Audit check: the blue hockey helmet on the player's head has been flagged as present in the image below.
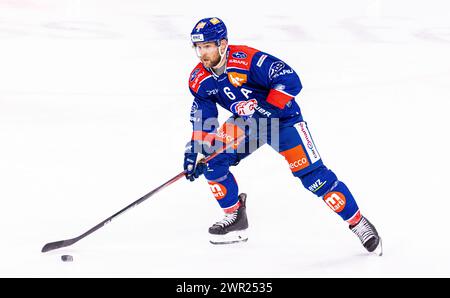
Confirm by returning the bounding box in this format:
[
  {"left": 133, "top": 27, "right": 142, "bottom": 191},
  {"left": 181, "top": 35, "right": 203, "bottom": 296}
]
[{"left": 191, "top": 17, "right": 228, "bottom": 45}]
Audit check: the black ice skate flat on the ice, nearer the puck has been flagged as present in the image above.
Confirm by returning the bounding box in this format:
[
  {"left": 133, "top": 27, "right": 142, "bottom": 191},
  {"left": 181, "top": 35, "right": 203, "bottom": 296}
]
[{"left": 209, "top": 193, "right": 248, "bottom": 244}]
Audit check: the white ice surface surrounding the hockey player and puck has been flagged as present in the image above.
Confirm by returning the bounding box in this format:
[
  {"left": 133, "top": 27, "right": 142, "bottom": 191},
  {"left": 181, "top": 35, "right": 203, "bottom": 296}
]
[{"left": 0, "top": 0, "right": 450, "bottom": 277}]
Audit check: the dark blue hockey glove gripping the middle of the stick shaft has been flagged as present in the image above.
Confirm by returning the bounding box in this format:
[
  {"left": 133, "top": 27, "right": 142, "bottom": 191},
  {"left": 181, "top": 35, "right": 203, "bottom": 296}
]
[{"left": 183, "top": 141, "right": 207, "bottom": 181}]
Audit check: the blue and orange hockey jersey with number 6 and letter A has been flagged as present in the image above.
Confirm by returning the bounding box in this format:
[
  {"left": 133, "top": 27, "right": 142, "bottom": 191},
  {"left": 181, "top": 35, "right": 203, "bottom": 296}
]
[{"left": 189, "top": 45, "right": 302, "bottom": 139}]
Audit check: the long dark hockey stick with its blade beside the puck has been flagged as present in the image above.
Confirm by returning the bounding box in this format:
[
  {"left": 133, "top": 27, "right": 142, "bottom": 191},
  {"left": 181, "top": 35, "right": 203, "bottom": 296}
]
[{"left": 42, "top": 136, "right": 245, "bottom": 252}]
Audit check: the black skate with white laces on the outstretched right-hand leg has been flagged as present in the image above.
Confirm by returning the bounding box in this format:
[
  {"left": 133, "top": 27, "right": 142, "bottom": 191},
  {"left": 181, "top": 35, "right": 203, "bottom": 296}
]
[{"left": 349, "top": 216, "right": 383, "bottom": 256}]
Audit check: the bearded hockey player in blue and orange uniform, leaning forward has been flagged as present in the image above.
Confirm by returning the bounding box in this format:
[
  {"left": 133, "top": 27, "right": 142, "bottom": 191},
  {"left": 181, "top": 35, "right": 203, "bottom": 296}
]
[{"left": 184, "top": 17, "right": 381, "bottom": 255}]
